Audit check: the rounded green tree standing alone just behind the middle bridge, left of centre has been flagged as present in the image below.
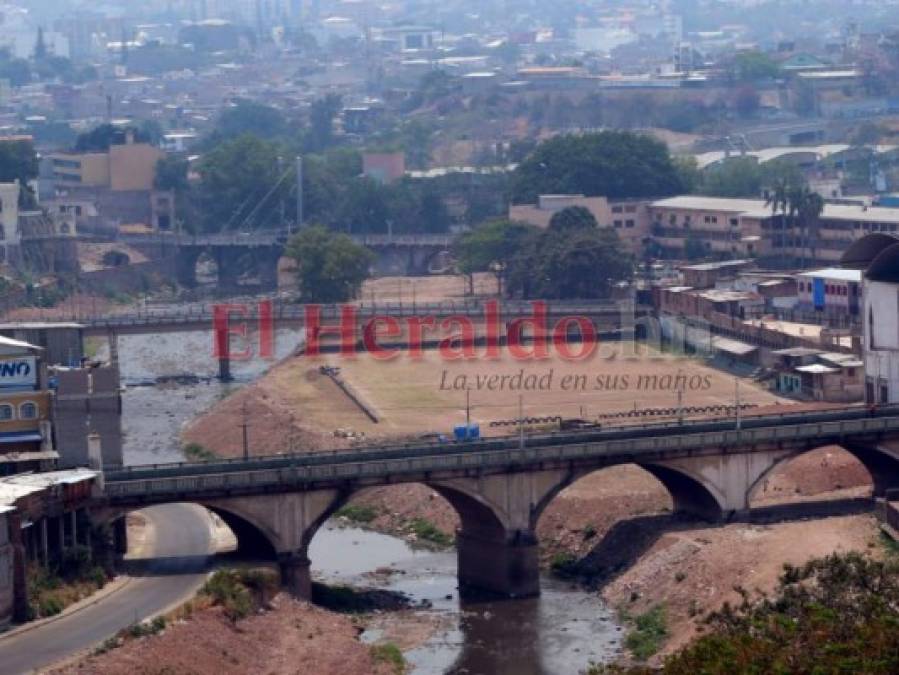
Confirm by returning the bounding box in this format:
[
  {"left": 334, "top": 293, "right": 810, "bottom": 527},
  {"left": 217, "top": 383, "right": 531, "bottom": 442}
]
[{"left": 286, "top": 225, "right": 374, "bottom": 303}]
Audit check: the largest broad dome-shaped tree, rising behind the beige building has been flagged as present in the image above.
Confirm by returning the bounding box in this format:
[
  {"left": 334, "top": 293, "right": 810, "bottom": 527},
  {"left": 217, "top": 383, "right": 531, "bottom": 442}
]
[{"left": 512, "top": 131, "right": 684, "bottom": 203}]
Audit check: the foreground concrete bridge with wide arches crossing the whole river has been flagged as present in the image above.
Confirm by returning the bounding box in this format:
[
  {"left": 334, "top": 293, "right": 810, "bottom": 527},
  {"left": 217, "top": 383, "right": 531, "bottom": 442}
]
[{"left": 94, "top": 407, "right": 899, "bottom": 598}]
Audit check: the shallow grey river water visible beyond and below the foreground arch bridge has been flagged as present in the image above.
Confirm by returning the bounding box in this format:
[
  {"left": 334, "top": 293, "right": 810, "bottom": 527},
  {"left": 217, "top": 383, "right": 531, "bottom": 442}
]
[{"left": 119, "top": 333, "right": 622, "bottom": 675}]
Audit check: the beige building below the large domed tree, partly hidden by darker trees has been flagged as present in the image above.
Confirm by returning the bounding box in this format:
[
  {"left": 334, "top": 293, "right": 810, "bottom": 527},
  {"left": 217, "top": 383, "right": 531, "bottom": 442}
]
[{"left": 509, "top": 195, "right": 649, "bottom": 255}]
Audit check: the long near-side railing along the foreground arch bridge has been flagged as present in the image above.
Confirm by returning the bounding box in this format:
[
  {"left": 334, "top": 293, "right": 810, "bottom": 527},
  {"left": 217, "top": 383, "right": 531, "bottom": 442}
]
[{"left": 106, "top": 417, "right": 899, "bottom": 500}]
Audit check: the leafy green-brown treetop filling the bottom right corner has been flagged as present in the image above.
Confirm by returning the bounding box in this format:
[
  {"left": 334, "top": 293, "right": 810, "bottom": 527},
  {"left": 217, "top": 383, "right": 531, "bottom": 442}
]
[{"left": 588, "top": 553, "right": 899, "bottom": 675}]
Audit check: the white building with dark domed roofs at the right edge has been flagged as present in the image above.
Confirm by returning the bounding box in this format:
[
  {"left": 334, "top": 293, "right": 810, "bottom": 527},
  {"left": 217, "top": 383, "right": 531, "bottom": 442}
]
[{"left": 843, "top": 233, "right": 899, "bottom": 404}]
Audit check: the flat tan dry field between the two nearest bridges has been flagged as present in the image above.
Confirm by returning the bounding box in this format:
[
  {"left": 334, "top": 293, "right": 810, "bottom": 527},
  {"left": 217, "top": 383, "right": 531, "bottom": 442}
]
[{"left": 261, "top": 345, "right": 789, "bottom": 437}]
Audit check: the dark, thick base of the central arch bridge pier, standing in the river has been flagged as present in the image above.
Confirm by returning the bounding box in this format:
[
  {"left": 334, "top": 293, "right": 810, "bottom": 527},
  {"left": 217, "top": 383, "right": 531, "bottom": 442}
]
[{"left": 456, "top": 532, "right": 540, "bottom": 598}]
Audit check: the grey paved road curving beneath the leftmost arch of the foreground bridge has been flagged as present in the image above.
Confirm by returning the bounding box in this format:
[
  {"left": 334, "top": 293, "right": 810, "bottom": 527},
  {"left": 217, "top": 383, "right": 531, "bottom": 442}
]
[{"left": 0, "top": 504, "right": 212, "bottom": 675}]
